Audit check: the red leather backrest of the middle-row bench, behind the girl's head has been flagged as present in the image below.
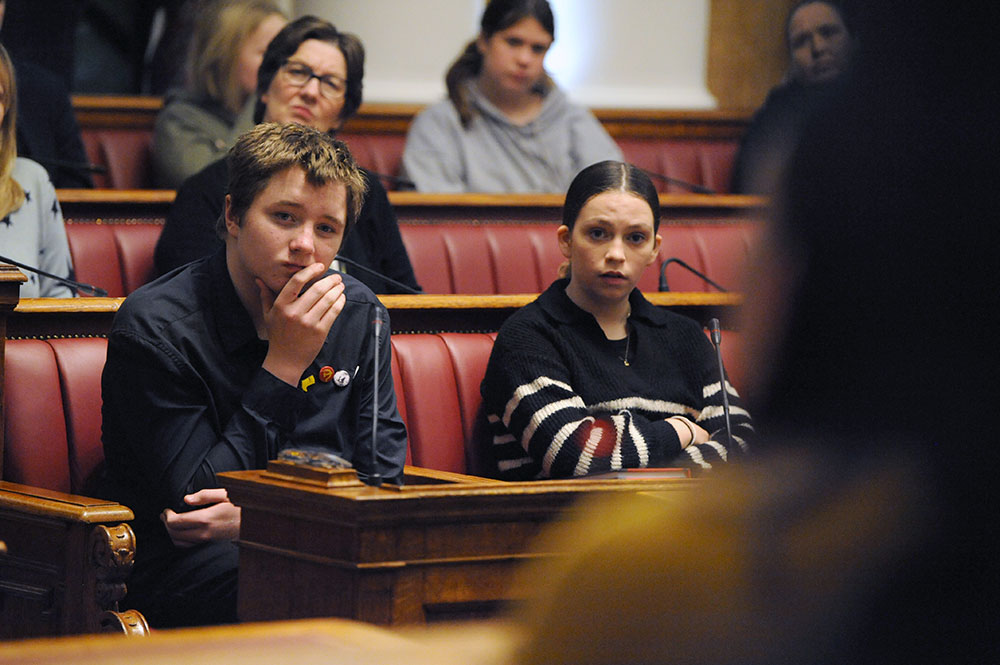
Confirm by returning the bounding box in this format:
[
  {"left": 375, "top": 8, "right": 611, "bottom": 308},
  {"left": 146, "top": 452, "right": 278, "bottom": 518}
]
[{"left": 60, "top": 222, "right": 759, "bottom": 297}]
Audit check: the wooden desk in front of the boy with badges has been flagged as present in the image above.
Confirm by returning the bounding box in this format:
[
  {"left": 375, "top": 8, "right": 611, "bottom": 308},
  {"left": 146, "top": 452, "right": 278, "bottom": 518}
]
[{"left": 219, "top": 467, "right": 697, "bottom": 625}]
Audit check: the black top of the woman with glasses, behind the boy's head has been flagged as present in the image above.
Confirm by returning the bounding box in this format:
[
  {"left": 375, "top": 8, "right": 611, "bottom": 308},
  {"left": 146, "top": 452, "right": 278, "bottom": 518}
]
[{"left": 154, "top": 158, "right": 420, "bottom": 293}]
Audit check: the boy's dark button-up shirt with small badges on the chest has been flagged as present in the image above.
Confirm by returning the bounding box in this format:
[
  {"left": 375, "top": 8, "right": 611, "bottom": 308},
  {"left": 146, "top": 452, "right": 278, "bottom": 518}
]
[{"left": 101, "top": 251, "right": 406, "bottom": 548}]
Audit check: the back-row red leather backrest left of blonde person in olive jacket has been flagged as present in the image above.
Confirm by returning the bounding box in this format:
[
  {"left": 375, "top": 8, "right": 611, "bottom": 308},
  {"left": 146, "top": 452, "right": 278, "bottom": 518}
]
[{"left": 80, "top": 128, "right": 153, "bottom": 189}]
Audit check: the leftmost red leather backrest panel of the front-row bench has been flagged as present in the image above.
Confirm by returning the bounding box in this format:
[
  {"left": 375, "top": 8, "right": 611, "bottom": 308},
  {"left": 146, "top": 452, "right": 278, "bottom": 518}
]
[{"left": 3, "top": 339, "right": 73, "bottom": 492}]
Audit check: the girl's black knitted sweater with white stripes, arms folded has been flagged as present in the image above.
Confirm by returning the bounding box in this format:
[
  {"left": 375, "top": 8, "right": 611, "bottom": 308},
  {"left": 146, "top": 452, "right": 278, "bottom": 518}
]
[{"left": 480, "top": 280, "right": 753, "bottom": 480}]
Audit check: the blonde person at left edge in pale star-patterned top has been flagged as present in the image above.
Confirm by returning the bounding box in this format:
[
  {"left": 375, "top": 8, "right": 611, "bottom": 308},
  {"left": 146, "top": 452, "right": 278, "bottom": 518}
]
[{"left": 0, "top": 46, "right": 75, "bottom": 298}]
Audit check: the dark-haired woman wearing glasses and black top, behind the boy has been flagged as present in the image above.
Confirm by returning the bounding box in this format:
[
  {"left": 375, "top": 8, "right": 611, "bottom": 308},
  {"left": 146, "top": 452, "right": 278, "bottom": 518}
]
[{"left": 155, "top": 16, "right": 420, "bottom": 293}]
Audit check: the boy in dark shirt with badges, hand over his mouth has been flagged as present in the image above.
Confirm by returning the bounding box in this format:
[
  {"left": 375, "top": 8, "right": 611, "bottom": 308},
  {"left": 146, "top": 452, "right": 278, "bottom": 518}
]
[{"left": 97, "top": 123, "right": 407, "bottom": 627}]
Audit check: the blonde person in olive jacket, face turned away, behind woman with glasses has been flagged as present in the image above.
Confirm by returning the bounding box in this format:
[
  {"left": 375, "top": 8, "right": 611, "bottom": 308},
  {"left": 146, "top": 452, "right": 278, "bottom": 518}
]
[{"left": 153, "top": 0, "right": 288, "bottom": 189}]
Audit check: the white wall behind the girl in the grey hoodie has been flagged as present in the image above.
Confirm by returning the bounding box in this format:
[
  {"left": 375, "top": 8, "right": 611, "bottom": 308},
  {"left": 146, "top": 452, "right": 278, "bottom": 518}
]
[{"left": 290, "top": 0, "right": 715, "bottom": 109}]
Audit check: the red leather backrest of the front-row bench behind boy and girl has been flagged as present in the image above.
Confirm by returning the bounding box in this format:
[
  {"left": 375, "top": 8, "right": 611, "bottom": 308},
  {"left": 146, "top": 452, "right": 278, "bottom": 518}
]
[{"left": 3, "top": 331, "right": 742, "bottom": 494}]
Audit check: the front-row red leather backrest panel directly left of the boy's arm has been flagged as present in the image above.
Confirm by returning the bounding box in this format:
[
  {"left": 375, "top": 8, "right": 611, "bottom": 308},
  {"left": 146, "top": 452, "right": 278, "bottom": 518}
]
[{"left": 49, "top": 337, "right": 108, "bottom": 494}]
